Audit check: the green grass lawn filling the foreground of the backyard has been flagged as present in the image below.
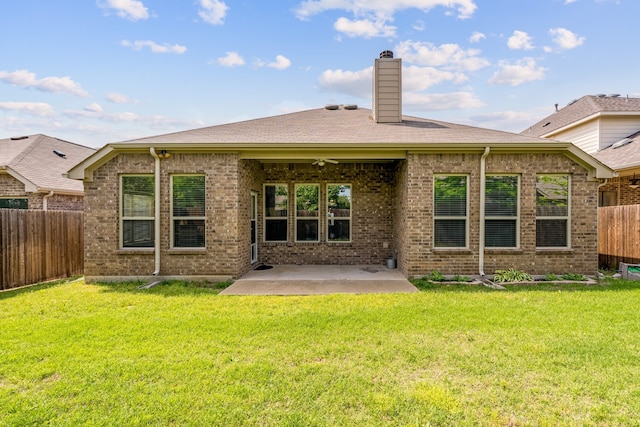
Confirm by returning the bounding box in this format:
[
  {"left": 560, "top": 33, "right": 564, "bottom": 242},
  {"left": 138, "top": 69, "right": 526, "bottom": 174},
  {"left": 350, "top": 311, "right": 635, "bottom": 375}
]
[{"left": 0, "top": 280, "right": 640, "bottom": 426}]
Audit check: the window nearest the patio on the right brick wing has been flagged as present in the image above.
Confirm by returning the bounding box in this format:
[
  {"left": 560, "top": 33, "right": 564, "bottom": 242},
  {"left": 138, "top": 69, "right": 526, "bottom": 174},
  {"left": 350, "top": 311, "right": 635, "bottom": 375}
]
[{"left": 433, "top": 175, "right": 468, "bottom": 248}]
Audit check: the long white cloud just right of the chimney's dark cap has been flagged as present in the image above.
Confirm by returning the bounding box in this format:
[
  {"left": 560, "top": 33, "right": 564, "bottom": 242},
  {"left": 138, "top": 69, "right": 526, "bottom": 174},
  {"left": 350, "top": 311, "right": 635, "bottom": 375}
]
[{"left": 396, "top": 40, "right": 489, "bottom": 71}]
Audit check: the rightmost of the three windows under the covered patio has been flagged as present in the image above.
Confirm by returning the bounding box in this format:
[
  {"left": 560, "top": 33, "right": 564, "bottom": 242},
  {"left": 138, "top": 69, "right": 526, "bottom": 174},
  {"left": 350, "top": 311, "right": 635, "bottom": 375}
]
[{"left": 327, "top": 184, "right": 351, "bottom": 242}]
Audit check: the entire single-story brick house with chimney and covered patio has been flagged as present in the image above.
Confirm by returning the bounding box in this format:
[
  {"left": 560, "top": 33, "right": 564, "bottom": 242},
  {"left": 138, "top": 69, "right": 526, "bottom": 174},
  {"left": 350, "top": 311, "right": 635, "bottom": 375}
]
[{"left": 69, "top": 55, "right": 613, "bottom": 281}]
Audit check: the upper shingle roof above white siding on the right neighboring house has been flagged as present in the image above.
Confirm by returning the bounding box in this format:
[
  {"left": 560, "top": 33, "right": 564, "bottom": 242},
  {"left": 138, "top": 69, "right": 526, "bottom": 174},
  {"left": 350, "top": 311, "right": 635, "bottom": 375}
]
[{"left": 520, "top": 95, "right": 640, "bottom": 137}]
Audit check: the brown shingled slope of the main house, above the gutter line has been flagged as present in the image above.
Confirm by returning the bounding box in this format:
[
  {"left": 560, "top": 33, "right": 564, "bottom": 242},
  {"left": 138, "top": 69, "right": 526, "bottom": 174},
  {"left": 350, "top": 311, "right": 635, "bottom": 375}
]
[{"left": 118, "top": 108, "right": 548, "bottom": 145}]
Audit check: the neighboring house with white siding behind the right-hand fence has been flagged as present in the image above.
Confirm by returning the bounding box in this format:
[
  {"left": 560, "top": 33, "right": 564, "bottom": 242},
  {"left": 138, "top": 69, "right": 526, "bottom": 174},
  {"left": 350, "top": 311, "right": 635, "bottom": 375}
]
[{"left": 522, "top": 94, "right": 640, "bottom": 206}]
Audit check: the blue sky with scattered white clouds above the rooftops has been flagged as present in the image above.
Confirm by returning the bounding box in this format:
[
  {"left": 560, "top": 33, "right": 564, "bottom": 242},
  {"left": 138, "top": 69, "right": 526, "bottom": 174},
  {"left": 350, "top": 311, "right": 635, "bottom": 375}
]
[{"left": 0, "top": 0, "right": 640, "bottom": 147}]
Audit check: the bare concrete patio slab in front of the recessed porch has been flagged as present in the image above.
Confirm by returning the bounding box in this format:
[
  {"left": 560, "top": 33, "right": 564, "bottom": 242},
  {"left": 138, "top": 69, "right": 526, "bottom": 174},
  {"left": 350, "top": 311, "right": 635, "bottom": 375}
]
[{"left": 220, "top": 265, "right": 418, "bottom": 295}]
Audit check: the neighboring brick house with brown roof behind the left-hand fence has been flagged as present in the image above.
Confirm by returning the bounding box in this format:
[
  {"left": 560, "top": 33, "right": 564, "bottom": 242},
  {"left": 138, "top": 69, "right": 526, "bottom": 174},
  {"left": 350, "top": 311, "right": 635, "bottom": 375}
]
[{"left": 0, "top": 135, "right": 96, "bottom": 211}]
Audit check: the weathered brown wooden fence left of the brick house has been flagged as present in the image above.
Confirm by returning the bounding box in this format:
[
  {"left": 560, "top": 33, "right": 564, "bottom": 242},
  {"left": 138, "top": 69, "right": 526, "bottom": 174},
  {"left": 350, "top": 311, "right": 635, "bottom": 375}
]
[{"left": 0, "top": 209, "right": 84, "bottom": 289}]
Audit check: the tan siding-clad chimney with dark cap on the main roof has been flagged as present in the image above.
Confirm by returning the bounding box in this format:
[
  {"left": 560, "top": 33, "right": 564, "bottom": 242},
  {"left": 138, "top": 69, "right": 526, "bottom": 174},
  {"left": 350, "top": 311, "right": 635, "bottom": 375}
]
[{"left": 373, "top": 50, "right": 402, "bottom": 123}]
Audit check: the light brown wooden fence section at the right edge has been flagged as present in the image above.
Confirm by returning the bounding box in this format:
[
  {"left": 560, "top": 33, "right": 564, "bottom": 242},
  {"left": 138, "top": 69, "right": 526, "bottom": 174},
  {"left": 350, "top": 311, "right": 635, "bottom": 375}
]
[{"left": 598, "top": 205, "right": 640, "bottom": 269}]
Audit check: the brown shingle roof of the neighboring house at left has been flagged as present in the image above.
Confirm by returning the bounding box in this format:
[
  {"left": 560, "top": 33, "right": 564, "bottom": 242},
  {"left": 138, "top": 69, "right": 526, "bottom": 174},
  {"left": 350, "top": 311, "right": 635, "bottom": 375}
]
[{"left": 0, "top": 134, "right": 96, "bottom": 194}]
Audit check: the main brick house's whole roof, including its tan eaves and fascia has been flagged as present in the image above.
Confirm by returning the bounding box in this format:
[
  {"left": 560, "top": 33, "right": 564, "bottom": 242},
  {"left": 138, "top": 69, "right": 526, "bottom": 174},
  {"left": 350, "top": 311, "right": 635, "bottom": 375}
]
[{"left": 69, "top": 107, "right": 611, "bottom": 179}]
